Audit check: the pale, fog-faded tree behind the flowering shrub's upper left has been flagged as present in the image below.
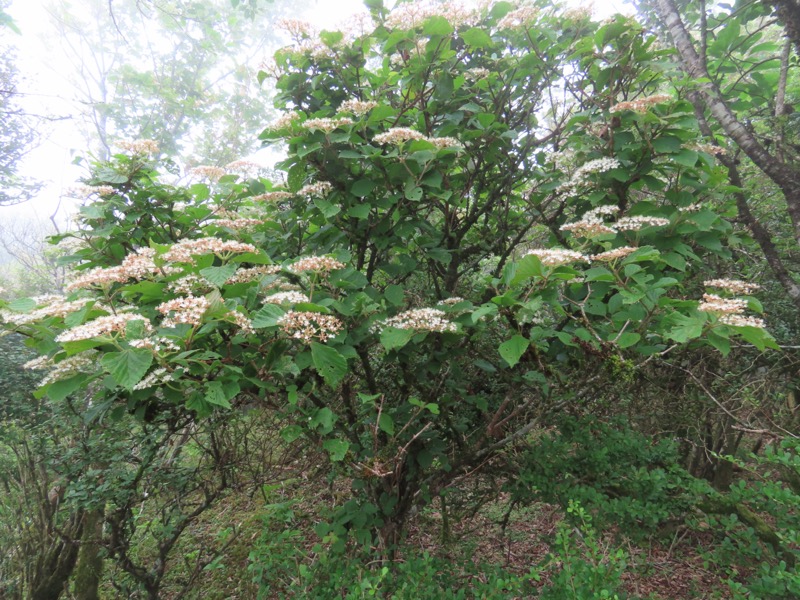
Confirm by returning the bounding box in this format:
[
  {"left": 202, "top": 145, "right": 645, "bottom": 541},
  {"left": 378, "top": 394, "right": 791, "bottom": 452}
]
[{"left": 45, "top": 0, "right": 306, "bottom": 164}]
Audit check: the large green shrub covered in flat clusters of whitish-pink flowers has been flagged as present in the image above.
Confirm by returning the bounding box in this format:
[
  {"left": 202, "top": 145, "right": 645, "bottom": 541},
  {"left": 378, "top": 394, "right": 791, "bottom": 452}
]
[{"left": 4, "top": 0, "right": 774, "bottom": 548}]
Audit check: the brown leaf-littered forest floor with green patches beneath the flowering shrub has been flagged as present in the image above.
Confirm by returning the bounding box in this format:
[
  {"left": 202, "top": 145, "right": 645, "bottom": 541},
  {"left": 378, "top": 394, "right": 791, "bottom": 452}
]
[{"left": 163, "top": 473, "right": 741, "bottom": 600}]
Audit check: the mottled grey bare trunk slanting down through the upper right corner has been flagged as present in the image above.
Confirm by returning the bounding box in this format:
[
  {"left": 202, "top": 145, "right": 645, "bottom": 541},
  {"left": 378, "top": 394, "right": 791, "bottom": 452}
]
[{"left": 654, "top": 0, "right": 800, "bottom": 244}]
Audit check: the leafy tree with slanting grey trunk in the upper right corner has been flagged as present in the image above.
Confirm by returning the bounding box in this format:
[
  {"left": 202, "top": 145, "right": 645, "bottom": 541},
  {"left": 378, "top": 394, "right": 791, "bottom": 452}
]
[{"left": 640, "top": 0, "right": 800, "bottom": 307}]
